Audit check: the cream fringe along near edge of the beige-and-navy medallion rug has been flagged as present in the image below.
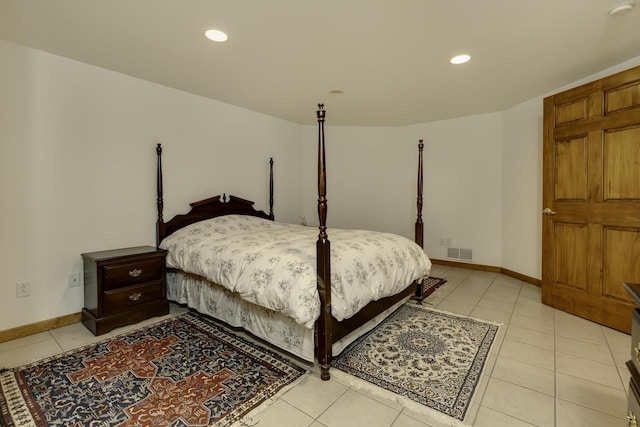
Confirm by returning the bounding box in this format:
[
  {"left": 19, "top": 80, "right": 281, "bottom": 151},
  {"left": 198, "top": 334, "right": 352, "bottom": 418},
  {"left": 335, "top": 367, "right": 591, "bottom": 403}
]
[{"left": 331, "top": 368, "right": 471, "bottom": 427}]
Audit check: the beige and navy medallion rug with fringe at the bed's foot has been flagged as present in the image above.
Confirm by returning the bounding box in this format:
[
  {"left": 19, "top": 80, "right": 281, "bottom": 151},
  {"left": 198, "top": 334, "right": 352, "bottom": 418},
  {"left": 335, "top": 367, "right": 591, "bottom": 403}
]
[{"left": 331, "top": 302, "right": 499, "bottom": 426}]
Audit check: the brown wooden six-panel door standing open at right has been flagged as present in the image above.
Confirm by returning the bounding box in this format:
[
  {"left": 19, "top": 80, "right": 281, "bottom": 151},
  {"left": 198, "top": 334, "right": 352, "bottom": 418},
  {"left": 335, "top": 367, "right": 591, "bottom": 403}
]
[{"left": 542, "top": 67, "right": 640, "bottom": 333}]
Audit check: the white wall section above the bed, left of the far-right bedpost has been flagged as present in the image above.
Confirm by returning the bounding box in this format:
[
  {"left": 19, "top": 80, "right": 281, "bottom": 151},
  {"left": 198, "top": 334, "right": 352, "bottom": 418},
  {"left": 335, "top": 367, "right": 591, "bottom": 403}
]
[{"left": 303, "top": 124, "right": 417, "bottom": 240}]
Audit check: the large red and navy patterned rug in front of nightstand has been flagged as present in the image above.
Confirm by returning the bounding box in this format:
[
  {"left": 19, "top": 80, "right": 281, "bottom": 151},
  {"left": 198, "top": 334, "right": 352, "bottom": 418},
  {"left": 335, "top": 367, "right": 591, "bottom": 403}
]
[{"left": 0, "top": 313, "right": 305, "bottom": 426}]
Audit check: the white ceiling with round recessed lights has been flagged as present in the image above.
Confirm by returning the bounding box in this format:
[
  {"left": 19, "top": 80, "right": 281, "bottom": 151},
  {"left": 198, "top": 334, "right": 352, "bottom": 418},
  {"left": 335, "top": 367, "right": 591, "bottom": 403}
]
[{"left": 0, "top": 0, "right": 640, "bottom": 126}]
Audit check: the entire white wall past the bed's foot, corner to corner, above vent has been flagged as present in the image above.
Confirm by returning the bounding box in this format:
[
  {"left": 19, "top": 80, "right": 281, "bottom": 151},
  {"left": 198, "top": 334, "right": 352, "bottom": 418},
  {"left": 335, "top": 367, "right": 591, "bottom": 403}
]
[{"left": 303, "top": 113, "right": 502, "bottom": 266}]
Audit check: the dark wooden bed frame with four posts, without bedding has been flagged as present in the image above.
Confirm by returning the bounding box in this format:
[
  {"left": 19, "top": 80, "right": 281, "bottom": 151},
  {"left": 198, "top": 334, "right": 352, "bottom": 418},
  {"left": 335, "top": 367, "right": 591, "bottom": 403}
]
[{"left": 156, "top": 104, "right": 424, "bottom": 380}]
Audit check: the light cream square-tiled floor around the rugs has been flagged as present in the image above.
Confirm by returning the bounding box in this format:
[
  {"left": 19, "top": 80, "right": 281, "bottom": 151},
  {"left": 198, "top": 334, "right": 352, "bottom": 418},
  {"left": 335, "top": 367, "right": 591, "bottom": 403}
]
[{"left": 0, "top": 265, "right": 631, "bottom": 427}]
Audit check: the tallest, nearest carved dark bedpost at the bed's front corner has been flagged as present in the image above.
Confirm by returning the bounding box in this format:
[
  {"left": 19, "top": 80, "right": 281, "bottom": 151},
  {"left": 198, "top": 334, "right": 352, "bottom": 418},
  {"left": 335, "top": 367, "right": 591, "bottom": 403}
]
[{"left": 316, "top": 104, "right": 333, "bottom": 381}]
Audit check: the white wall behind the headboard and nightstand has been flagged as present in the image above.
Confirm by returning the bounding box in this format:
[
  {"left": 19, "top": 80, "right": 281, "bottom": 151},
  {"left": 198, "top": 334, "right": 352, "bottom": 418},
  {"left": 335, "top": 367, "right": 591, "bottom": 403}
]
[{"left": 0, "top": 41, "right": 302, "bottom": 330}]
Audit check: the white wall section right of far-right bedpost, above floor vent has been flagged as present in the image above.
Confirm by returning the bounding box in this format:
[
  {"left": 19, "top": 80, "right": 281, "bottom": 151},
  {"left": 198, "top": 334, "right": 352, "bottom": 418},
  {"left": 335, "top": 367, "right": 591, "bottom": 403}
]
[{"left": 405, "top": 113, "right": 502, "bottom": 266}]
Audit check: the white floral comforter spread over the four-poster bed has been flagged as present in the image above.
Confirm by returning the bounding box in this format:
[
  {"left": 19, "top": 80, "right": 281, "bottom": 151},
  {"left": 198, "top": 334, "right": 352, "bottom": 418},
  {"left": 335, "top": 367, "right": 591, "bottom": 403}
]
[{"left": 160, "top": 215, "right": 431, "bottom": 328}]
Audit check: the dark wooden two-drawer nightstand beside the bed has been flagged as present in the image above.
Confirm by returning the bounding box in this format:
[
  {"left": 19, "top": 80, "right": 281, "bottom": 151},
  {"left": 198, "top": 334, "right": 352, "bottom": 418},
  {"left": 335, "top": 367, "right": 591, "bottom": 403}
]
[{"left": 82, "top": 246, "right": 169, "bottom": 335}]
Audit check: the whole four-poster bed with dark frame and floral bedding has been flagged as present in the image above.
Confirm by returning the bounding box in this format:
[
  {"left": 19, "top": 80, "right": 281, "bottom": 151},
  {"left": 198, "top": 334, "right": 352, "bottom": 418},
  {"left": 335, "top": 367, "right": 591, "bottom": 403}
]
[{"left": 156, "top": 104, "right": 431, "bottom": 380}]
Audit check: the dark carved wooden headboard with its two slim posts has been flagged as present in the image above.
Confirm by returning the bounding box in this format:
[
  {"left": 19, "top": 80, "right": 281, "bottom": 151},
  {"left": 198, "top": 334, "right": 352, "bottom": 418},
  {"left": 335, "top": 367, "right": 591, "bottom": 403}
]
[{"left": 156, "top": 144, "right": 274, "bottom": 247}]
